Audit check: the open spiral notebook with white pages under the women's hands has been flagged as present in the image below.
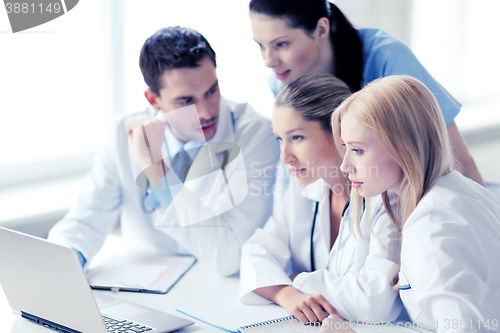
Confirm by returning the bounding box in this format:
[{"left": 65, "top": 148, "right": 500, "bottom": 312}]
[{"left": 177, "top": 296, "right": 431, "bottom": 333}]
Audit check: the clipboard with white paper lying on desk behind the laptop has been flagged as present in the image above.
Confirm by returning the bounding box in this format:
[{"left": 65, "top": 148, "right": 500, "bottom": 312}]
[{"left": 87, "top": 255, "right": 196, "bottom": 294}]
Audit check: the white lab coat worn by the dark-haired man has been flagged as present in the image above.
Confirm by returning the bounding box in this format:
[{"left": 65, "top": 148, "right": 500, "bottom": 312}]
[{"left": 49, "top": 97, "right": 279, "bottom": 276}]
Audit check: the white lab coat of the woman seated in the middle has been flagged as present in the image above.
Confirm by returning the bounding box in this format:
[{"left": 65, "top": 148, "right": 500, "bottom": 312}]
[{"left": 240, "top": 164, "right": 401, "bottom": 322}]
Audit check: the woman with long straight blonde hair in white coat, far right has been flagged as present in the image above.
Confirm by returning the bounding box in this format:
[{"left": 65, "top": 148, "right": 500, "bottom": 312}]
[{"left": 324, "top": 76, "right": 500, "bottom": 332}]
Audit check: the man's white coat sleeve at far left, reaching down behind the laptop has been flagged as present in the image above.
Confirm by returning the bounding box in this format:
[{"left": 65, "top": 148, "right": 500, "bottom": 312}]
[{"left": 48, "top": 118, "right": 126, "bottom": 263}]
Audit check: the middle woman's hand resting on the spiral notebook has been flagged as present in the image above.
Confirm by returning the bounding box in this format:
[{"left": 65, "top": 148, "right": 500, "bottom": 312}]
[{"left": 275, "top": 286, "right": 338, "bottom": 324}]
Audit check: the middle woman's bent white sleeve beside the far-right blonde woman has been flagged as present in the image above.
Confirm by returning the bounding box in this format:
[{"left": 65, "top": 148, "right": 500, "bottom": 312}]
[{"left": 293, "top": 208, "right": 401, "bottom": 322}]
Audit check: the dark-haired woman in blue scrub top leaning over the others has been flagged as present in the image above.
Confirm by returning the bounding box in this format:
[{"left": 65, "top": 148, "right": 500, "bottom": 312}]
[{"left": 249, "top": 0, "right": 484, "bottom": 186}]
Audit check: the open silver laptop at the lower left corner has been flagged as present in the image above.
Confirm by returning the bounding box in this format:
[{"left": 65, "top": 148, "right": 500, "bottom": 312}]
[{"left": 0, "top": 227, "right": 194, "bottom": 333}]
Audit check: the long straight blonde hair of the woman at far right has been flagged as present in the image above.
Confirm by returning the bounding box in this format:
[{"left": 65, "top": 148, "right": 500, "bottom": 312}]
[{"left": 332, "top": 75, "right": 454, "bottom": 230}]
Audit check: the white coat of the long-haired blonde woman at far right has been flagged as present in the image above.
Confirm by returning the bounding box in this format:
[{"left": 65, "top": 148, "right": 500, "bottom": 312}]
[{"left": 399, "top": 171, "right": 500, "bottom": 332}]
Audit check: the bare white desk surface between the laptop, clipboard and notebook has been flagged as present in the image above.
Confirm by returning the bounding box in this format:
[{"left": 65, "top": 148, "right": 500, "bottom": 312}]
[{"left": 0, "top": 262, "right": 239, "bottom": 333}]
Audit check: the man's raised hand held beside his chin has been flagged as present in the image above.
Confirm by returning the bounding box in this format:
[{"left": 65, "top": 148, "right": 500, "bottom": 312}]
[{"left": 127, "top": 115, "right": 168, "bottom": 187}]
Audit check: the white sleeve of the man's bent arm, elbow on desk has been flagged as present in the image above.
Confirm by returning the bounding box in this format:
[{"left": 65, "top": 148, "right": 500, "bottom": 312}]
[{"left": 155, "top": 113, "right": 279, "bottom": 276}]
